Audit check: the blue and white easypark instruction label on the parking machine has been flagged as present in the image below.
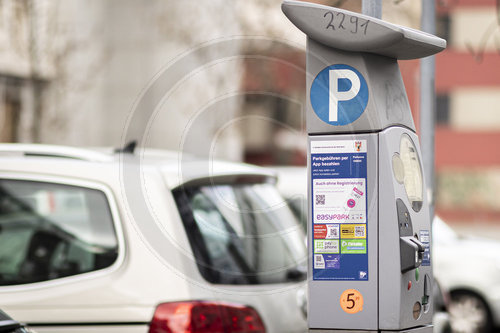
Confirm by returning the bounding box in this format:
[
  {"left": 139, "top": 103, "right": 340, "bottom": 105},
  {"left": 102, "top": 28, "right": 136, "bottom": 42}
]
[{"left": 311, "top": 140, "right": 368, "bottom": 281}]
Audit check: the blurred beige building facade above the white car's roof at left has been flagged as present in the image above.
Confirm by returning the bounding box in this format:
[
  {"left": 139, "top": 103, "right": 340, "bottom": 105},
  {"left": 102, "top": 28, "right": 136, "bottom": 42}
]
[{"left": 0, "top": 0, "right": 248, "bottom": 160}]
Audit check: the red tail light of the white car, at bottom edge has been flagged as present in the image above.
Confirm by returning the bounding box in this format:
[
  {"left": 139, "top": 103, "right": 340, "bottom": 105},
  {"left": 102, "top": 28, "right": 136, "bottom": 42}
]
[{"left": 149, "top": 301, "right": 266, "bottom": 333}]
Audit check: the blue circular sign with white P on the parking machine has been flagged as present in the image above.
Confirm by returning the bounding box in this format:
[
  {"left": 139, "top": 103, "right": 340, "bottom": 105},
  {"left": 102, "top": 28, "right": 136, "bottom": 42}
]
[{"left": 310, "top": 64, "right": 368, "bottom": 126}]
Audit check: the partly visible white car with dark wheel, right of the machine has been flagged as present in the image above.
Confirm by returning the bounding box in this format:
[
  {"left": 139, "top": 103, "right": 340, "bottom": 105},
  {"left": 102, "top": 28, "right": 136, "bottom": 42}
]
[{"left": 433, "top": 217, "right": 500, "bottom": 333}]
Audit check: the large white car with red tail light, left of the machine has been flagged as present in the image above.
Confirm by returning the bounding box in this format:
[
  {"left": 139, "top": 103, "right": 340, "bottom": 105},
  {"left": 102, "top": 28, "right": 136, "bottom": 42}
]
[{"left": 0, "top": 144, "right": 307, "bottom": 333}]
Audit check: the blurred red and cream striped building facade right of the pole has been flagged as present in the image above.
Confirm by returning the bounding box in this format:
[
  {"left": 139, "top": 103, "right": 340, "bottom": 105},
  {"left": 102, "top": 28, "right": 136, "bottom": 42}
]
[{"left": 414, "top": 0, "right": 500, "bottom": 223}]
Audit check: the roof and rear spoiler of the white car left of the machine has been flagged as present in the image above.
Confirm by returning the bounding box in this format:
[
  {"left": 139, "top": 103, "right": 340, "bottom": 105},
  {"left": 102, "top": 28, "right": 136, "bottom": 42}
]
[{"left": 0, "top": 143, "right": 275, "bottom": 189}]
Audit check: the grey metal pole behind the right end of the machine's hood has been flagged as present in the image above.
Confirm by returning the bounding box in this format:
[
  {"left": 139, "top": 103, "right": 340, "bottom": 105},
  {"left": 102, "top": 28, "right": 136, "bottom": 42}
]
[{"left": 420, "top": 0, "right": 436, "bottom": 221}]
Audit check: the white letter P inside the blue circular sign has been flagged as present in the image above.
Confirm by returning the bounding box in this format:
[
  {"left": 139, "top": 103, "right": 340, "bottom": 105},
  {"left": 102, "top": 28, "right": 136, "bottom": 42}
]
[{"left": 328, "top": 69, "right": 361, "bottom": 121}]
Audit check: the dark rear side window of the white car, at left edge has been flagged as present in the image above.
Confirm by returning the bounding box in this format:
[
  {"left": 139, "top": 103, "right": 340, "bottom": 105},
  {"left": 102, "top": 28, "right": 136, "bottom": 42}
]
[{"left": 0, "top": 179, "right": 118, "bottom": 286}]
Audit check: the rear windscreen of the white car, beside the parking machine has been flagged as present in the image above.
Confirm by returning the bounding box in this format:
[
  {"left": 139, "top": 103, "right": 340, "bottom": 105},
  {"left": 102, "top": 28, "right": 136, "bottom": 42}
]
[{"left": 174, "top": 180, "right": 306, "bottom": 284}]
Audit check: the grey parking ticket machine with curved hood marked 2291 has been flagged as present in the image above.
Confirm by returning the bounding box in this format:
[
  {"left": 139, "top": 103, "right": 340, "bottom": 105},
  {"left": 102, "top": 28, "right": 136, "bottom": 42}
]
[{"left": 282, "top": 0, "right": 446, "bottom": 332}]
